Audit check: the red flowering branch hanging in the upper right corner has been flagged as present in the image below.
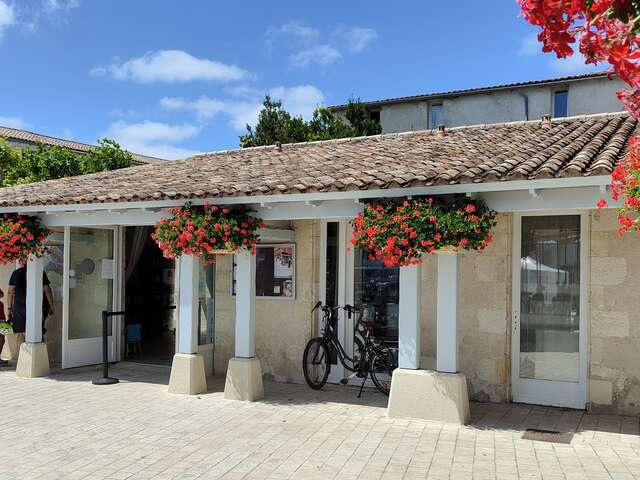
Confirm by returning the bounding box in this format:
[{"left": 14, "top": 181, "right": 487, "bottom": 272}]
[{"left": 518, "top": 0, "right": 640, "bottom": 234}]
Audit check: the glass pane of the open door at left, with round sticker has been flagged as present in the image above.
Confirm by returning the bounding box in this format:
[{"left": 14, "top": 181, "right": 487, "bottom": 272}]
[{"left": 69, "top": 228, "right": 115, "bottom": 340}]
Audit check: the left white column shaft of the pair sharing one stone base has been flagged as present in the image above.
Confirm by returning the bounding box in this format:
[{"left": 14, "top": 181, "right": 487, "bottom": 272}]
[{"left": 398, "top": 265, "right": 422, "bottom": 370}]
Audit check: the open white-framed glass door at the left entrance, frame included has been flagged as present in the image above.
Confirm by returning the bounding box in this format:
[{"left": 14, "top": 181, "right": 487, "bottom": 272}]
[{"left": 62, "top": 227, "right": 120, "bottom": 368}]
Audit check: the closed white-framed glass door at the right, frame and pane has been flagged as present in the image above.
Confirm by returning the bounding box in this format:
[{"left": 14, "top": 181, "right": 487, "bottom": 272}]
[{"left": 512, "top": 215, "right": 586, "bottom": 408}]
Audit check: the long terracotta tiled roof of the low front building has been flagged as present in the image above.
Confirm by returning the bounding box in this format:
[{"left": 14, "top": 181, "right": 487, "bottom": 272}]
[{"left": 0, "top": 113, "right": 636, "bottom": 207}]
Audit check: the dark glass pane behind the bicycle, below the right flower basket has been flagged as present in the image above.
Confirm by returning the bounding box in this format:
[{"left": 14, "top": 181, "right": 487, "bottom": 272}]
[{"left": 354, "top": 249, "right": 400, "bottom": 343}]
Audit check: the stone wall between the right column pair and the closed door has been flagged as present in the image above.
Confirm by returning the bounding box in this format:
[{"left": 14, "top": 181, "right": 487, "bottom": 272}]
[{"left": 421, "top": 214, "right": 513, "bottom": 402}]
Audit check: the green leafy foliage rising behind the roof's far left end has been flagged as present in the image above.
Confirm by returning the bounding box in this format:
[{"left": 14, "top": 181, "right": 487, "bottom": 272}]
[{"left": 0, "top": 138, "right": 132, "bottom": 186}]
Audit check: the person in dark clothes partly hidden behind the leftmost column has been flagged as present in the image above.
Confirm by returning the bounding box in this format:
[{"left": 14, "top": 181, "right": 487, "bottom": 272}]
[{"left": 7, "top": 262, "right": 53, "bottom": 352}]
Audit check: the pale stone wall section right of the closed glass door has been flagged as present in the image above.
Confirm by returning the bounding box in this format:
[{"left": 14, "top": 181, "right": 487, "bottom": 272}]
[{"left": 589, "top": 210, "right": 640, "bottom": 415}]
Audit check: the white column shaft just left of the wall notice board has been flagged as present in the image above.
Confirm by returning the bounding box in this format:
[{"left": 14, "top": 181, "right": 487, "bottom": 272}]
[{"left": 235, "top": 250, "right": 256, "bottom": 358}]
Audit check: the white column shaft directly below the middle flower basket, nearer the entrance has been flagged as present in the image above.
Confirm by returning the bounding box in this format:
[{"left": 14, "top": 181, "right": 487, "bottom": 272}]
[{"left": 177, "top": 255, "right": 200, "bottom": 353}]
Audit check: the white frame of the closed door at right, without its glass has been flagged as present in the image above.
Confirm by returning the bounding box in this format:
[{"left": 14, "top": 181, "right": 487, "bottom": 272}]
[{"left": 511, "top": 210, "right": 589, "bottom": 409}]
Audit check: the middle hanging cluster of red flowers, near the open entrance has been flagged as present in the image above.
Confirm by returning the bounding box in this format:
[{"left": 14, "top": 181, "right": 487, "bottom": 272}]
[{"left": 152, "top": 203, "right": 263, "bottom": 264}]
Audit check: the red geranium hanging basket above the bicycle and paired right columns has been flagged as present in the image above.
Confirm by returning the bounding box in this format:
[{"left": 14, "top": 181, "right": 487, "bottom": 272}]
[{"left": 351, "top": 198, "right": 496, "bottom": 267}]
